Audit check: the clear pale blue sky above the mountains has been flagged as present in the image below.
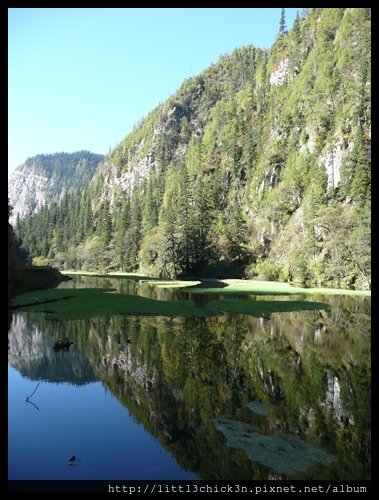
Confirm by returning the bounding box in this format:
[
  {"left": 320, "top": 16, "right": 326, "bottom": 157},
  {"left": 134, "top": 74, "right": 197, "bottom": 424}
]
[{"left": 8, "top": 8, "right": 301, "bottom": 173}]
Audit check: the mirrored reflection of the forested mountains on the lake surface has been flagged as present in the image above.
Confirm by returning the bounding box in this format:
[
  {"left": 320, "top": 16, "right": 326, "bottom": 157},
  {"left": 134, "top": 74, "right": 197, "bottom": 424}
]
[{"left": 9, "top": 292, "right": 370, "bottom": 479}]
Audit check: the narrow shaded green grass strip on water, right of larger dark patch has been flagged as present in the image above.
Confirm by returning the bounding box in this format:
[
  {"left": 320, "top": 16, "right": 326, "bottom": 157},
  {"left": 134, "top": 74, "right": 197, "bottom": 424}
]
[{"left": 208, "top": 300, "right": 330, "bottom": 317}]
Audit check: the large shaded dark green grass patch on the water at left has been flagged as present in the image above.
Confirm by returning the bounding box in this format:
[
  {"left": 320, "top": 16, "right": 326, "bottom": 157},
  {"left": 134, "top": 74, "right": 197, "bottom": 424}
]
[{"left": 12, "top": 288, "right": 219, "bottom": 320}]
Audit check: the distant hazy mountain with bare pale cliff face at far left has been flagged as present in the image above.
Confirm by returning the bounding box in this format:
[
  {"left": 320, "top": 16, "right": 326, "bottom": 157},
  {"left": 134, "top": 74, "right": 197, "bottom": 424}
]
[{"left": 8, "top": 151, "right": 104, "bottom": 223}]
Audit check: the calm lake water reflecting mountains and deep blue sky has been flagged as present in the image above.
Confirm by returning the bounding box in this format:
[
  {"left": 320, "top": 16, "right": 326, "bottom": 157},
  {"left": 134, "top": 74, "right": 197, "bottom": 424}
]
[{"left": 8, "top": 277, "right": 371, "bottom": 480}]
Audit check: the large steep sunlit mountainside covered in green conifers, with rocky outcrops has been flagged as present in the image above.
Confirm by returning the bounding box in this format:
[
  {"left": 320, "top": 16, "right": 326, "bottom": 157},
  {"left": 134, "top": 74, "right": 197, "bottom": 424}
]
[{"left": 16, "top": 8, "right": 371, "bottom": 288}]
